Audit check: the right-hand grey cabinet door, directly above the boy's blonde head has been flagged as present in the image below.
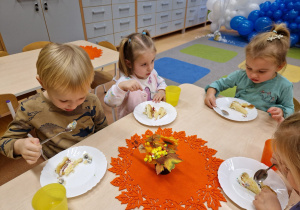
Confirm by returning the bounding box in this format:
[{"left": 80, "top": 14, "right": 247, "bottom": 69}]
[{"left": 41, "top": 0, "right": 84, "bottom": 43}]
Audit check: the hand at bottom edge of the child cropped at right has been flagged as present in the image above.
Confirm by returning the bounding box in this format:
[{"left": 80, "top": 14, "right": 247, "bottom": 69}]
[{"left": 253, "top": 187, "right": 281, "bottom": 210}]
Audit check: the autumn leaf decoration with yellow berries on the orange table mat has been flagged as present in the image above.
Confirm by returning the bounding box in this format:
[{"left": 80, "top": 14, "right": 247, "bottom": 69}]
[{"left": 139, "top": 134, "right": 182, "bottom": 175}]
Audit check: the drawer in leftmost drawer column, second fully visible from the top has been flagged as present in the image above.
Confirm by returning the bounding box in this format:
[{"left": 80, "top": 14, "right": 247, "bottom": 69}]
[{"left": 86, "top": 20, "right": 113, "bottom": 38}]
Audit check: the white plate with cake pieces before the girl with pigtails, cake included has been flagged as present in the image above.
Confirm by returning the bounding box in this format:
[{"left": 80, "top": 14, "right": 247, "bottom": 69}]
[{"left": 133, "top": 101, "right": 177, "bottom": 126}]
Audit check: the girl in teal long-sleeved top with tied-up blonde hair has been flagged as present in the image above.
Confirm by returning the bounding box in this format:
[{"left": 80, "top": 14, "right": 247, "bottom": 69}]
[{"left": 205, "top": 24, "right": 294, "bottom": 122}]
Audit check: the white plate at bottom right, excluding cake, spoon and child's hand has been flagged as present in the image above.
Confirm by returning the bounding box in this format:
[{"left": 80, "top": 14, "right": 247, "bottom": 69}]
[{"left": 218, "top": 157, "right": 288, "bottom": 210}]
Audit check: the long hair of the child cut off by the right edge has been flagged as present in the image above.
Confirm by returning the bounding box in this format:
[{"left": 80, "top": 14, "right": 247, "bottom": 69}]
[{"left": 273, "top": 112, "right": 300, "bottom": 188}]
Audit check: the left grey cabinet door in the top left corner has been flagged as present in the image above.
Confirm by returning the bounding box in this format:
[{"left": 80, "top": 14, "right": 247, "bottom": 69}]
[{"left": 0, "top": 0, "right": 49, "bottom": 54}]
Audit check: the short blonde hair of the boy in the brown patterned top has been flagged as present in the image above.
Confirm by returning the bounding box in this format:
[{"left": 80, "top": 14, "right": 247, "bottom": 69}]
[{"left": 36, "top": 43, "right": 94, "bottom": 92}]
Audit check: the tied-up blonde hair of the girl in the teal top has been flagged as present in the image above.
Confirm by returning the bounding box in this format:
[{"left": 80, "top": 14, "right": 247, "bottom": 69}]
[{"left": 245, "top": 24, "right": 290, "bottom": 66}]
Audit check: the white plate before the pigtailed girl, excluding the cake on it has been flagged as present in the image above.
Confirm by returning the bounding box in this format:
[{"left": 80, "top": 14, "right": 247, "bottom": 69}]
[{"left": 133, "top": 101, "right": 177, "bottom": 126}]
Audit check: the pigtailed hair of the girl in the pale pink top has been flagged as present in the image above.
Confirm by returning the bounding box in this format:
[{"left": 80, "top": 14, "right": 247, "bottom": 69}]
[{"left": 119, "top": 30, "right": 156, "bottom": 77}]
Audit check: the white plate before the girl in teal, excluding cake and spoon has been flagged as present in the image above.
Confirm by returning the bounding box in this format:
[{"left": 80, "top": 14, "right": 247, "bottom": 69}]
[{"left": 213, "top": 97, "right": 257, "bottom": 121}]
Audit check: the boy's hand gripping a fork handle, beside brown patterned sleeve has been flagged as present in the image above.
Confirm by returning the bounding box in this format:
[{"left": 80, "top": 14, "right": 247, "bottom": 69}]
[{"left": 14, "top": 138, "right": 42, "bottom": 164}]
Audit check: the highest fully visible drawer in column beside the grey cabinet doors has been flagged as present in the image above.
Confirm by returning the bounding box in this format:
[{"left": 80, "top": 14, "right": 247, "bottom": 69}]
[{"left": 83, "top": 6, "right": 112, "bottom": 23}]
